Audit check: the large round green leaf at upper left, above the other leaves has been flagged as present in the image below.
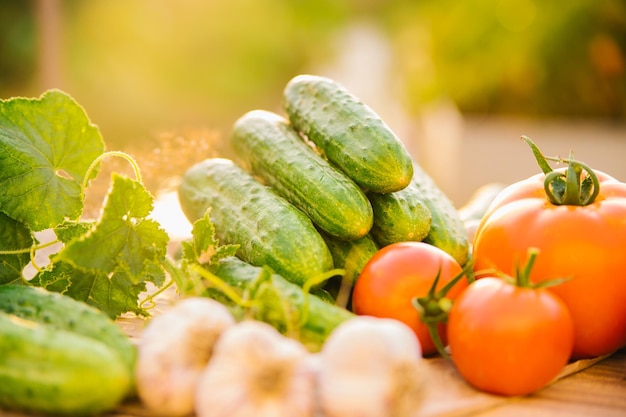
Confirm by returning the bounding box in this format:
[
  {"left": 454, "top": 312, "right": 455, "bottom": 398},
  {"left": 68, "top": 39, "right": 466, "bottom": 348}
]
[{"left": 0, "top": 90, "right": 105, "bottom": 231}]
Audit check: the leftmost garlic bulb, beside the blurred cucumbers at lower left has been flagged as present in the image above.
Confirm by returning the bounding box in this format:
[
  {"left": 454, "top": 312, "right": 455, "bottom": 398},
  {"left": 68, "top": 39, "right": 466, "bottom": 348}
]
[{"left": 135, "top": 297, "right": 236, "bottom": 417}]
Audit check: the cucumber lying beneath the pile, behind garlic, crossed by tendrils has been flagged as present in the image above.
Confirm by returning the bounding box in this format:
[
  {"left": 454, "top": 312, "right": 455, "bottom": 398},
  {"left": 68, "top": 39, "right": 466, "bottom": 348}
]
[{"left": 210, "top": 257, "right": 354, "bottom": 351}]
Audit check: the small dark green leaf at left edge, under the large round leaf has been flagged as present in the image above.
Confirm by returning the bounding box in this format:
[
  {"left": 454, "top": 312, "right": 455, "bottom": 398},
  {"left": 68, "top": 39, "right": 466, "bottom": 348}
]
[{"left": 0, "top": 212, "right": 35, "bottom": 285}]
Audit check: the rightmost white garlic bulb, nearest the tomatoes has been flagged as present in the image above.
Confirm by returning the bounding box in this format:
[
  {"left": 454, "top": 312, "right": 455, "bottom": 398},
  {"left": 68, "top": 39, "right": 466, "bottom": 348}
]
[{"left": 318, "top": 316, "right": 425, "bottom": 417}]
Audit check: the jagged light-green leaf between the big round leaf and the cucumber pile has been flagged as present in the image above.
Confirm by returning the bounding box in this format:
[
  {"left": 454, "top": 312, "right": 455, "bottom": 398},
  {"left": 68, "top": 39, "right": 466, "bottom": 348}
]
[{"left": 54, "top": 173, "right": 169, "bottom": 283}]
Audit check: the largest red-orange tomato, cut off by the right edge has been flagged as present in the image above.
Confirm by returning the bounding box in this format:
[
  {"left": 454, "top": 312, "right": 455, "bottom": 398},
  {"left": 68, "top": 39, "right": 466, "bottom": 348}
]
[{"left": 473, "top": 171, "right": 626, "bottom": 359}]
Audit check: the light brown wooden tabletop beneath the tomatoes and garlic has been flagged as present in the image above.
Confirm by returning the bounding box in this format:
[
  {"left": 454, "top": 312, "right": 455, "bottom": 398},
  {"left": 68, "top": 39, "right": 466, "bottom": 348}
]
[{"left": 107, "top": 349, "right": 626, "bottom": 417}]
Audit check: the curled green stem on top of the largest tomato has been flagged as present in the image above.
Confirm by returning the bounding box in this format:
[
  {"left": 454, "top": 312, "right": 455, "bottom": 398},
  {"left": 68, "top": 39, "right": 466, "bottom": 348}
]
[{"left": 522, "top": 136, "right": 600, "bottom": 206}]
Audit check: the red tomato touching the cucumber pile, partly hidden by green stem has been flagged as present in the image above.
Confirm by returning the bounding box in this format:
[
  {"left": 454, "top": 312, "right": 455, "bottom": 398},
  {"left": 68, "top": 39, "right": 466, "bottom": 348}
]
[{"left": 352, "top": 242, "right": 467, "bottom": 356}]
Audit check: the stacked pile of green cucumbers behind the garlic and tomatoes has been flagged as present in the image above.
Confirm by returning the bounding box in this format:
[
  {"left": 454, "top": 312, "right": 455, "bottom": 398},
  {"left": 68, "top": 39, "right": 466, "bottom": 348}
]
[{"left": 178, "top": 75, "right": 469, "bottom": 294}]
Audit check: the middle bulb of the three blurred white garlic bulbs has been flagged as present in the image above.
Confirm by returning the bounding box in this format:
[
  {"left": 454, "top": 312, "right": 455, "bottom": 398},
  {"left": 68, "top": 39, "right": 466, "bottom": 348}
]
[{"left": 195, "top": 320, "right": 315, "bottom": 417}]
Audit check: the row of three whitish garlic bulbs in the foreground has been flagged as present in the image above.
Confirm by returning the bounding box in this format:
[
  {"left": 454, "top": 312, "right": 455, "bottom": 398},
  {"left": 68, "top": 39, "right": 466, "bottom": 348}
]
[{"left": 132, "top": 297, "right": 424, "bottom": 417}]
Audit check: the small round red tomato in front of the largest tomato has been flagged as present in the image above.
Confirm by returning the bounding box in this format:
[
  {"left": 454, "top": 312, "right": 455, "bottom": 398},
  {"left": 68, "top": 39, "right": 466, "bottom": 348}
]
[{"left": 448, "top": 276, "right": 574, "bottom": 396}]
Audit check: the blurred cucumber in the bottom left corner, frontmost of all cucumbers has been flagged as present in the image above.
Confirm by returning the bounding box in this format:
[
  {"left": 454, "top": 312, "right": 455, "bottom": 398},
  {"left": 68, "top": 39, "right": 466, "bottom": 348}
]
[{"left": 0, "top": 312, "right": 130, "bottom": 416}]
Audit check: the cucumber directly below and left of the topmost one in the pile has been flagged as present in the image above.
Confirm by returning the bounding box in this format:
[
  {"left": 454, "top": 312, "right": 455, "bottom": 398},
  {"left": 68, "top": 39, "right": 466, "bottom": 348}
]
[{"left": 231, "top": 110, "right": 373, "bottom": 240}]
